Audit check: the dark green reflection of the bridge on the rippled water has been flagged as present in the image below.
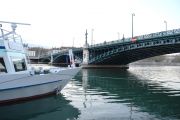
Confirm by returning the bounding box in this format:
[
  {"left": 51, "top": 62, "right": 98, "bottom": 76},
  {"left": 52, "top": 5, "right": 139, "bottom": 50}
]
[{"left": 76, "top": 69, "right": 180, "bottom": 119}]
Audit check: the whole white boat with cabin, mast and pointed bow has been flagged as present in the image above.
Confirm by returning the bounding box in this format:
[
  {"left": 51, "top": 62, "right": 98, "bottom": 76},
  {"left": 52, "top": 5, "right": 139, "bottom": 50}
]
[{"left": 0, "top": 21, "right": 80, "bottom": 104}]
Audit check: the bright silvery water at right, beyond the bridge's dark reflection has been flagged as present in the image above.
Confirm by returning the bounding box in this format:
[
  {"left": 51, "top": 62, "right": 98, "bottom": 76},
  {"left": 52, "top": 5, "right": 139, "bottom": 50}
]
[{"left": 129, "top": 66, "right": 180, "bottom": 90}]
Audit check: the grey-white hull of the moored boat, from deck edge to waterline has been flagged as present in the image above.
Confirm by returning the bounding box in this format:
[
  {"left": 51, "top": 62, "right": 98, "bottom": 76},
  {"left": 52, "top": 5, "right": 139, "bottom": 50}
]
[{"left": 0, "top": 68, "right": 79, "bottom": 104}]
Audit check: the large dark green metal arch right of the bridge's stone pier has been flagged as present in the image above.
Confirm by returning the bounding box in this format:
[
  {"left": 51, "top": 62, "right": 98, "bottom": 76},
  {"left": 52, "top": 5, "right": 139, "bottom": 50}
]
[{"left": 89, "top": 35, "right": 180, "bottom": 65}]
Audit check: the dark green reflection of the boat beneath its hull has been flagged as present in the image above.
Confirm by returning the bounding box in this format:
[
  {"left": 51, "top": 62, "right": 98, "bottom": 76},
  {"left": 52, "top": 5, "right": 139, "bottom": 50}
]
[{"left": 0, "top": 95, "right": 80, "bottom": 120}]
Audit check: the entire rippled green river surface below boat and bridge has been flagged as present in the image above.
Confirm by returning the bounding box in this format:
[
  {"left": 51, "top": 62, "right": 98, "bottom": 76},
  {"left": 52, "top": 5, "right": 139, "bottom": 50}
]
[{"left": 0, "top": 66, "right": 180, "bottom": 120}]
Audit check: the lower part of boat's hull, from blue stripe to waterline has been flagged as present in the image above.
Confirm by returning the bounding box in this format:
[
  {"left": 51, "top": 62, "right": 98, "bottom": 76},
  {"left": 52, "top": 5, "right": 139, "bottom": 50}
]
[{"left": 0, "top": 82, "right": 61, "bottom": 104}]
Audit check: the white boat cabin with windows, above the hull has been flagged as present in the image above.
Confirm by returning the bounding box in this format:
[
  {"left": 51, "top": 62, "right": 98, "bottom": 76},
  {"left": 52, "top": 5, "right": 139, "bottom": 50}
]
[{"left": 0, "top": 25, "right": 28, "bottom": 74}]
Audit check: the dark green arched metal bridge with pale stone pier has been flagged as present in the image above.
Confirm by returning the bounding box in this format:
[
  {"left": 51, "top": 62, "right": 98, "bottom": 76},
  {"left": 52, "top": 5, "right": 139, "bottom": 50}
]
[{"left": 40, "top": 29, "right": 180, "bottom": 66}]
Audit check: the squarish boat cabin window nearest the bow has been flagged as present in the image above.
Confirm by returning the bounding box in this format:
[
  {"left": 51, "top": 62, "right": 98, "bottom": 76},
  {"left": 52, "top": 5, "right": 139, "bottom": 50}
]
[{"left": 12, "top": 58, "right": 27, "bottom": 72}]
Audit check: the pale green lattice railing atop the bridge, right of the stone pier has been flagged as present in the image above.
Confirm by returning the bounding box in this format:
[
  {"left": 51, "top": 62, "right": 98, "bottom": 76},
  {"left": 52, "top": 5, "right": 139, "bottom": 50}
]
[{"left": 89, "top": 29, "right": 180, "bottom": 47}]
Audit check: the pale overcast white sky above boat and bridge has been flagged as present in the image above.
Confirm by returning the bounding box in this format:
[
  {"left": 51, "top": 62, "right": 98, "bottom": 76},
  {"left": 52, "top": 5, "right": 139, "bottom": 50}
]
[{"left": 0, "top": 0, "right": 180, "bottom": 48}]
